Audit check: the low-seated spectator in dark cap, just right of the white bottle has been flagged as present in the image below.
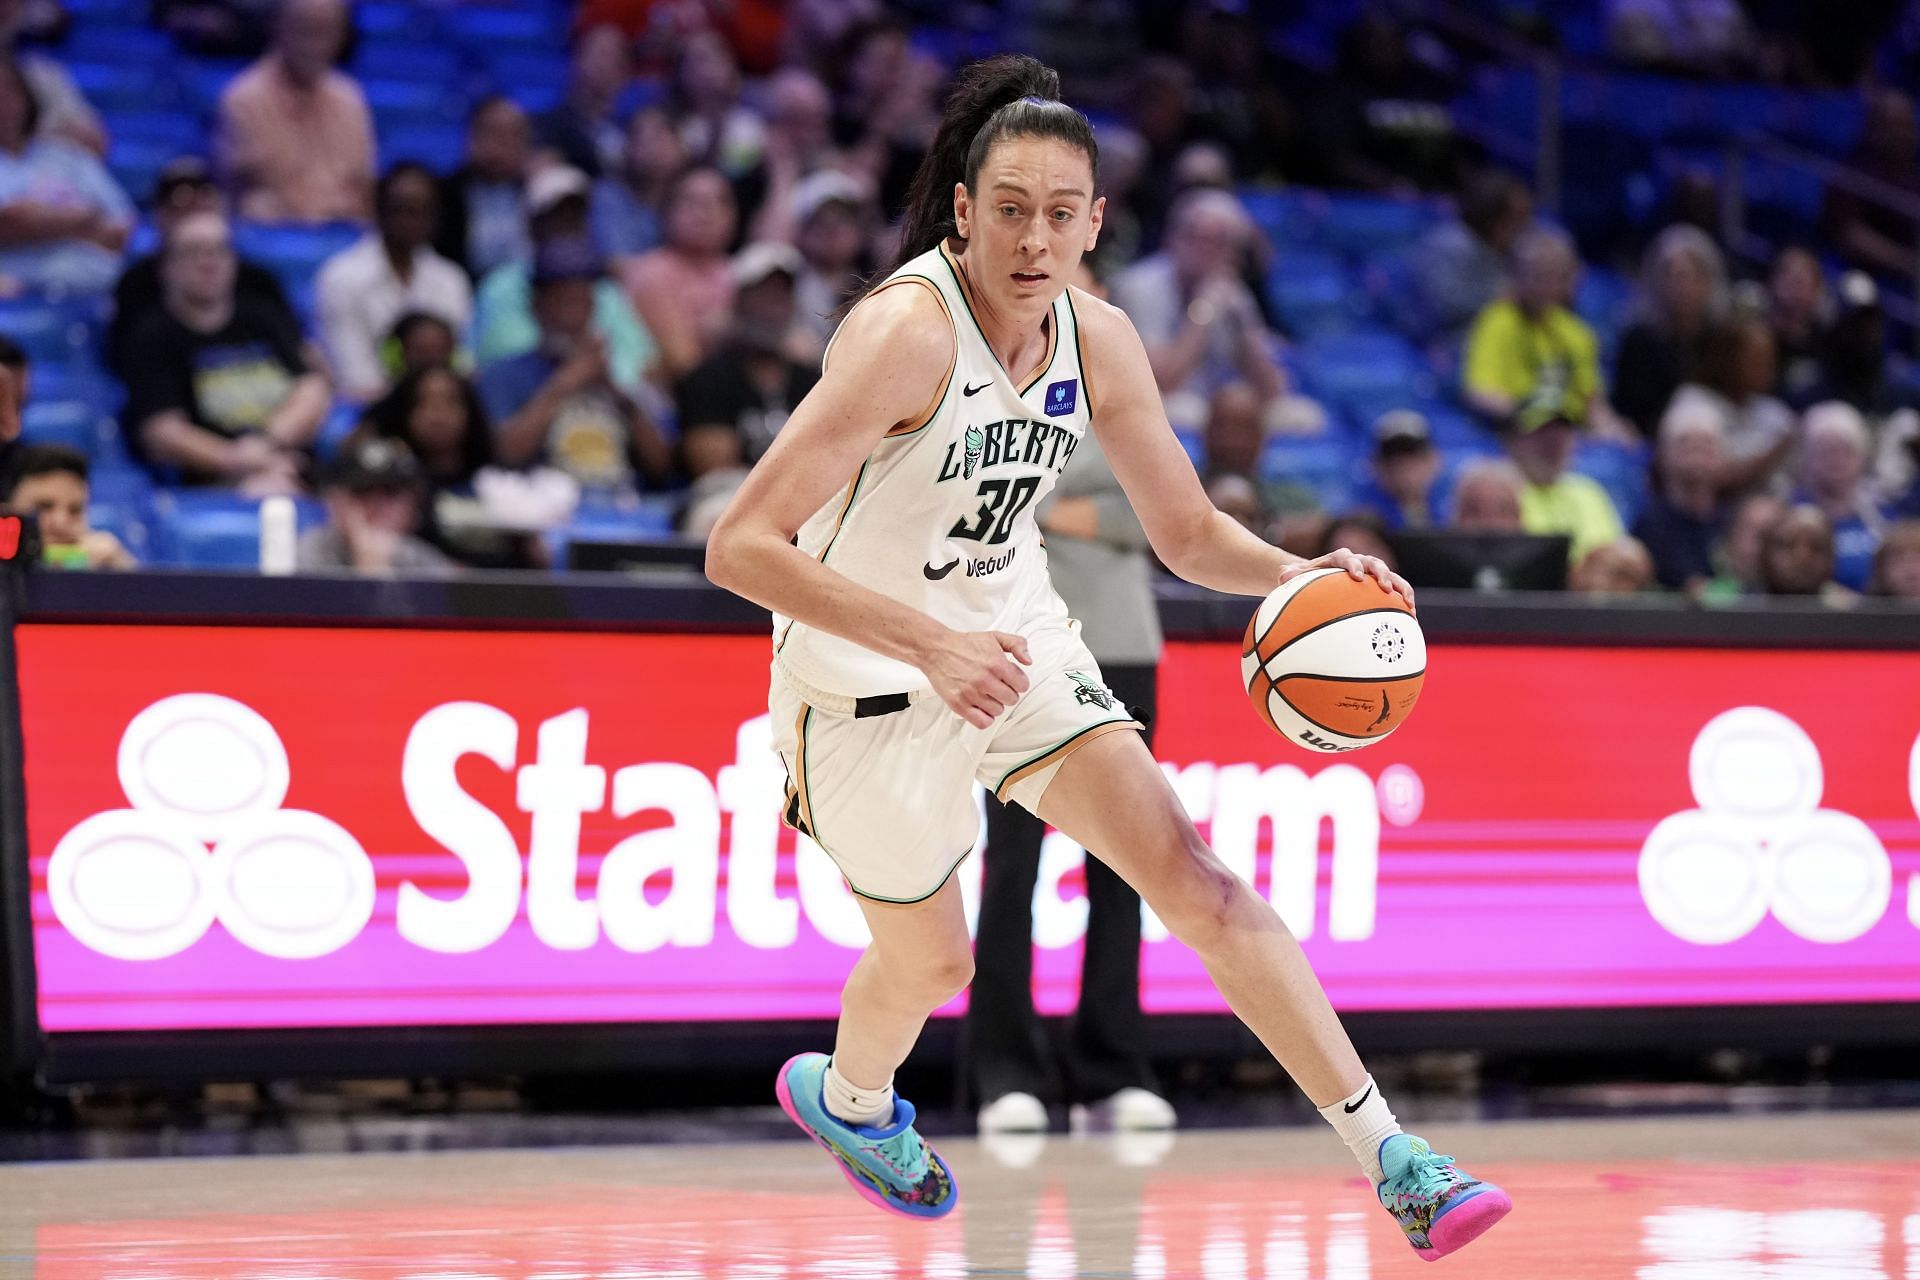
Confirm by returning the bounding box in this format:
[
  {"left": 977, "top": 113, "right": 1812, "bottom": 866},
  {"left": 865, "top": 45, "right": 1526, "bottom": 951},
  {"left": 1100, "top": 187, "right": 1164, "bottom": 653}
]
[{"left": 294, "top": 439, "right": 455, "bottom": 574}]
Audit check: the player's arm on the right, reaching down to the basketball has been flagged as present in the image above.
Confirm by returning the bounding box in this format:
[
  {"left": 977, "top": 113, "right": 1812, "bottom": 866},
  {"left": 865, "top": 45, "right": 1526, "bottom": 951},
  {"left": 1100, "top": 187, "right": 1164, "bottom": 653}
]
[{"left": 1073, "top": 294, "right": 1413, "bottom": 601}]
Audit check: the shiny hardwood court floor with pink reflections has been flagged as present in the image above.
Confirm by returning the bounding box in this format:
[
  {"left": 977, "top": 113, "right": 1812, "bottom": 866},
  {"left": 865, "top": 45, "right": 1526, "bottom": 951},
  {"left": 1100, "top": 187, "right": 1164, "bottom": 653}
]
[{"left": 0, "top": 1111, "right": 1920, "bottom": 1280}]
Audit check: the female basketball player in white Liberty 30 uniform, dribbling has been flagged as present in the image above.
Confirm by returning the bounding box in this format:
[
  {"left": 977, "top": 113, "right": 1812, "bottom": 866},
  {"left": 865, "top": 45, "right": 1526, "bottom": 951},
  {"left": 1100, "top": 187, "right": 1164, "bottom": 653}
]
[{"left": 707, "top": 56, "right": 1511, "bottom": 1259}]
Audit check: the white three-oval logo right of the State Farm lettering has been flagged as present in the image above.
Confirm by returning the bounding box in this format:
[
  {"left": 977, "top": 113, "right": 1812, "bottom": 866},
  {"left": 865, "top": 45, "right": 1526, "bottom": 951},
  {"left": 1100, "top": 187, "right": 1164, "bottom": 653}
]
[{"left": 1640, "top": 706, "right": 1920, "bottom": 946}]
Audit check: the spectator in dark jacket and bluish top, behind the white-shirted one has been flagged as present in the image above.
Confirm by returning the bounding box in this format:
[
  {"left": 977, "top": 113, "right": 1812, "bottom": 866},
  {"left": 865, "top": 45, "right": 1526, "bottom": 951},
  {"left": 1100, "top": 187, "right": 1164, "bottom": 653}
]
[{"left": 434, "top": 94, "right": 534, "bottom": 280}]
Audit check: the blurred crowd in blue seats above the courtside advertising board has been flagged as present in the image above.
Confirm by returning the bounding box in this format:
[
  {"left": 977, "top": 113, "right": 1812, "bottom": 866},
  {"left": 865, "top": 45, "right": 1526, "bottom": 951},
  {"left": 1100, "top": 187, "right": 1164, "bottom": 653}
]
[{"left": 0, "top": 0, "right": 1920, "bottom": 606}]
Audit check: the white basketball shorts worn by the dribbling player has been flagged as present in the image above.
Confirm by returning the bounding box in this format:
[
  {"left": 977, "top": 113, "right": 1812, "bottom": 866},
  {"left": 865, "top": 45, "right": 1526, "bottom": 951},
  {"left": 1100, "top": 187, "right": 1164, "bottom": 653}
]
[{"left": 768, "top": 622, "right": 1140, "bottom": 902}]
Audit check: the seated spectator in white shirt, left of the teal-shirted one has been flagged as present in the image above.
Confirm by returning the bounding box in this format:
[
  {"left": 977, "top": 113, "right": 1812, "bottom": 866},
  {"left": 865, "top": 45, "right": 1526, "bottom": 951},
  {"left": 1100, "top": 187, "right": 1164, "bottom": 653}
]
[{"left": 315, "top": 163, "right": 474, "bottom": 403}]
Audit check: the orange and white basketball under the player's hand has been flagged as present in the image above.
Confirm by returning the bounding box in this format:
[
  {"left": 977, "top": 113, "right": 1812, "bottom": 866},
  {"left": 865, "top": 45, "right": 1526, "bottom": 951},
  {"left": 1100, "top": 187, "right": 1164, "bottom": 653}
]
[{"left": 1240, "top": 568, "right": 1427, "bottom": 752}]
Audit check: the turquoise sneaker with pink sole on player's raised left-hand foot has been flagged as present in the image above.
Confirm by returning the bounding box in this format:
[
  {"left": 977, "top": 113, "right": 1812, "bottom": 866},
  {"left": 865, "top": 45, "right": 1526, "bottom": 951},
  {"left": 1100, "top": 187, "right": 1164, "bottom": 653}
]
[{"left": 774, "top": 1054, "right": 960, "bottom": 1219}]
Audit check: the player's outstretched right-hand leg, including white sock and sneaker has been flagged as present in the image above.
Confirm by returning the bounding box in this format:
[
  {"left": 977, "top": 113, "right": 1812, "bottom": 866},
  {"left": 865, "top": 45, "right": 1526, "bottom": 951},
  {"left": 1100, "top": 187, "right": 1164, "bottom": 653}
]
[{"left": 1037, "top": 733, "right": 1511, "bottom": 1261}]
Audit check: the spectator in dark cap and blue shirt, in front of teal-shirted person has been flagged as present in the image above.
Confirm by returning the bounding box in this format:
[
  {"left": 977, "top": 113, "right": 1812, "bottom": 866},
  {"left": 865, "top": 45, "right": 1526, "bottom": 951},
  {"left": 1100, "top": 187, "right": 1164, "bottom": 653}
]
[{"left": 478, "top": 240, "right": 672, "bottom": 493}]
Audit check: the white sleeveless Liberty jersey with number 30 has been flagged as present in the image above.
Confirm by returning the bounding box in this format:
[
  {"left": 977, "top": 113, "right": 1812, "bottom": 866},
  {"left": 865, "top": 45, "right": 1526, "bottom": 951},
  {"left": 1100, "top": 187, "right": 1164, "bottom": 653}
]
[{"left": 774, "top": 246, "right": 1092, "bottom": 697}]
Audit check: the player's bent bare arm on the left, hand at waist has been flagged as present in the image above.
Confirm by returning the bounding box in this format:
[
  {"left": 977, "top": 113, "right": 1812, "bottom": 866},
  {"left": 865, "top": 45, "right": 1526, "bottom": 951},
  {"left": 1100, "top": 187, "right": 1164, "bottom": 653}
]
[{"left": 707, "top": 284, "right": 1027, "bottom": 727}]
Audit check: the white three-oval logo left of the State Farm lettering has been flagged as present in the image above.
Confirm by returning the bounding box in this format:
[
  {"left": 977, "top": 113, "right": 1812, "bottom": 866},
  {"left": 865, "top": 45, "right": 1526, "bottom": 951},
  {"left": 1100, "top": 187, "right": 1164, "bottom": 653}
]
[{"left": 46, "top": 693, "right": 374, "bottom": 960}]
